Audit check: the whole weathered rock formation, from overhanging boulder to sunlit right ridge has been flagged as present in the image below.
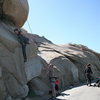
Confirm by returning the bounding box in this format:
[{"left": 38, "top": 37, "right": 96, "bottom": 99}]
[{"left": 0, "top": 0, "right": 100, "bottom": 100}]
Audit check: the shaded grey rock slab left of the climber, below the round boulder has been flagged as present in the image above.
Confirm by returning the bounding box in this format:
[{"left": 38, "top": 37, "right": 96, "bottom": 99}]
[{"left": 0, "top": 22, "right": 37, "bottom": 100}]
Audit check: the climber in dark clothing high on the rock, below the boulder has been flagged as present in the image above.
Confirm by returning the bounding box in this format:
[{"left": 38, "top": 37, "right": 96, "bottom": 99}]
[{"left": 14, "top": 29, "right": 30, "bottom": 62}]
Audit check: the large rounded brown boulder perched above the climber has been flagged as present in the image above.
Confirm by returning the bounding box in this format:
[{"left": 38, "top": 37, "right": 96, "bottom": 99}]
[{"left": 0, "top": 0, "right": 29, "bottom": 27}]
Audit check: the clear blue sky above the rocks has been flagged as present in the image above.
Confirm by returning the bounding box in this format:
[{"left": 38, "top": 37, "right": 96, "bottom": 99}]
[{"left": 24, "top": 0, "right": 100, "bottom": 53}]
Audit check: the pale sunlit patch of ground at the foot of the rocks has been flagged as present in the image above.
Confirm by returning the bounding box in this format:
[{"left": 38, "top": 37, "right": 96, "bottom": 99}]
[{"left": 57, "top": 85, "right": 100, "bottom": 100}]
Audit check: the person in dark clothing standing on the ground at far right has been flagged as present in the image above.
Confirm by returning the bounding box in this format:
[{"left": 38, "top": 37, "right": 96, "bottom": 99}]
[{"left": 85, "top": 64, "right": 93, "bottom": 86}]
